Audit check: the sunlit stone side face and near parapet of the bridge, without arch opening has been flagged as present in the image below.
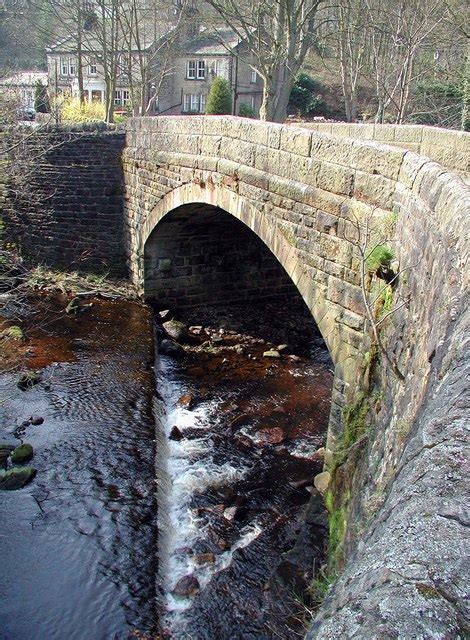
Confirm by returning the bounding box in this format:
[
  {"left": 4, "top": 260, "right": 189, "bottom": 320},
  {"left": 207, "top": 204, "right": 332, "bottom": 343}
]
[{"left": 124, "top": 117, "right": 470, "bottom": 639}]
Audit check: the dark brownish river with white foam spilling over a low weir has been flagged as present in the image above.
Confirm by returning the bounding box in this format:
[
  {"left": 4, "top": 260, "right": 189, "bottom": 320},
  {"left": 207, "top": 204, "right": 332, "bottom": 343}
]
[{"left": 0, "top": 299, "right": 332, "bottom": 640}]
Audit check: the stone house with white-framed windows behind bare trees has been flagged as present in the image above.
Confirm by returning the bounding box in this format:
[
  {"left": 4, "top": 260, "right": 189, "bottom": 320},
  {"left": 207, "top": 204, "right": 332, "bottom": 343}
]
[{"left": 46, "top": 14, "right": 262, "bottom": 115}]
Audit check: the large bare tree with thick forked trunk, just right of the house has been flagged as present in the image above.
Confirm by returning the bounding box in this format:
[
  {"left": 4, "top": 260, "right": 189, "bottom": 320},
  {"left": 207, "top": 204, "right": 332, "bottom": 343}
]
[{"left": 207, "top": 0, "right": 324, "bottom": 122}]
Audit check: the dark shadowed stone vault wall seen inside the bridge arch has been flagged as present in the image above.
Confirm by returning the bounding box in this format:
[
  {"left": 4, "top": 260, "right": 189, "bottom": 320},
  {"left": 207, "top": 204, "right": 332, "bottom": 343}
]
[{"left": 144, "top": 203, "right": 308, "bottom": 309}]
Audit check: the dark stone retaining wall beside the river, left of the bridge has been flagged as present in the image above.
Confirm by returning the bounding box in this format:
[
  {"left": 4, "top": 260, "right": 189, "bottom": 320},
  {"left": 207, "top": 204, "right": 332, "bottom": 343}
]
[{"left": 0, "top": 125, "right": 127, "bottom": 277}]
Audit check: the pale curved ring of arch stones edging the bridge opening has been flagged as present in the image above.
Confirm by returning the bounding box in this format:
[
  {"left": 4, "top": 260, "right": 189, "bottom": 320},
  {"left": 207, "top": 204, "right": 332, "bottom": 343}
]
[{"left": 138, "top": 182, "right": 363, "bottom": 448}]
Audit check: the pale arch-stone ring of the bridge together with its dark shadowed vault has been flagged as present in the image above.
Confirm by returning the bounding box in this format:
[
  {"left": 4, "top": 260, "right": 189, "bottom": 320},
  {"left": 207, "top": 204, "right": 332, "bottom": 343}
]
[{"left": 139, "top": 184, "right": 364, "bottom": 446}]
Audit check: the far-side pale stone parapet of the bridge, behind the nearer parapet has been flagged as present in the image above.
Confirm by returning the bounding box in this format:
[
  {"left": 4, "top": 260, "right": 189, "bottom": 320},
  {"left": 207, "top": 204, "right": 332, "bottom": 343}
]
[{"left": 292, "top": 122, "right": 470, "bottom": 183}]
